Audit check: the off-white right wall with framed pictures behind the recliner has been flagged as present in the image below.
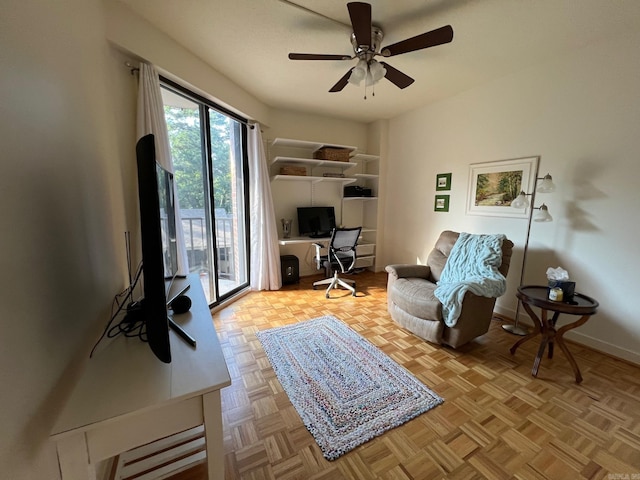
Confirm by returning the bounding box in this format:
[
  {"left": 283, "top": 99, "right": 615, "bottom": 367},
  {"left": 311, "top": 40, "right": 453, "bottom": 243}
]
[{"left": 384, "top": 31, "right": 640, "bottom": 363}]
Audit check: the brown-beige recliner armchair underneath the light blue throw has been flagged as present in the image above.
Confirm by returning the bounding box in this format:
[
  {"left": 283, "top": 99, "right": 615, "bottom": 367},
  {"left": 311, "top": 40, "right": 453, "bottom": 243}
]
[{"left": 386, "top": 231, "right": 513, "bottom": 348}]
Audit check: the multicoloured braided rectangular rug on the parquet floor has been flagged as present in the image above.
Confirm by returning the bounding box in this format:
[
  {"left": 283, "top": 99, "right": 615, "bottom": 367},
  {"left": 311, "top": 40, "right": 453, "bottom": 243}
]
[{"left": 256, "top": 316, "right": 443, "bottom": 460}]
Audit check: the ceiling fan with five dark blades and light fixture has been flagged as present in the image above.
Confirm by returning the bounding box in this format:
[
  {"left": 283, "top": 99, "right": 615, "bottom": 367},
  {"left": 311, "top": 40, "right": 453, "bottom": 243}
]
[{"left": 289, "top": 2, "right": 453, "bottom": 94}]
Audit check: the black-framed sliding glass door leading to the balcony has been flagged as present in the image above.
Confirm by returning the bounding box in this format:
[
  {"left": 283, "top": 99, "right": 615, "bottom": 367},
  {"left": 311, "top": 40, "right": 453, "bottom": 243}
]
[{"left": 162, "top": 80, "right": 249, "bottom": 305}]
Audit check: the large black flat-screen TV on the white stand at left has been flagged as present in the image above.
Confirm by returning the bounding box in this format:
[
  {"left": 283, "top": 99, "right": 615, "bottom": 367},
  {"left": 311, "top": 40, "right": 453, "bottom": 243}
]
[{"left": 136, "top": 134, "right": 177, "bottom": 363}]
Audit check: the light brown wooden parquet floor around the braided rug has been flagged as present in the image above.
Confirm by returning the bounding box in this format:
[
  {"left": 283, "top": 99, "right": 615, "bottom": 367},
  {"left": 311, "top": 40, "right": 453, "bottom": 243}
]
[{"left": 173, "top": 272, "right": 640, "bottom": 480}]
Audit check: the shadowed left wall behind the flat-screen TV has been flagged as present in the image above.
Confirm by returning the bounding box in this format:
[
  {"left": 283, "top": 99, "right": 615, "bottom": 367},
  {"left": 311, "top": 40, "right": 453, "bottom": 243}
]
[{"left": 0, "top": 0, "right": 126, "bottom": 480}]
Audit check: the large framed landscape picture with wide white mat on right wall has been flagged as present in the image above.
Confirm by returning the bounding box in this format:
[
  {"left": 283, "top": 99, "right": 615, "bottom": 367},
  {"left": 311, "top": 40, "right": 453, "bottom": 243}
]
[{"left": 467, "top": 157, "right": 540, "bottom": 218}]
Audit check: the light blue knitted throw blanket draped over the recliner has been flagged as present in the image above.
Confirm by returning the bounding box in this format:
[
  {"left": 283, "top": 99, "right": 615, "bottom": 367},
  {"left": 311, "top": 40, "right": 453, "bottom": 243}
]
[{"left": 433, "top": 232, "right": 507, "bottom": 327}]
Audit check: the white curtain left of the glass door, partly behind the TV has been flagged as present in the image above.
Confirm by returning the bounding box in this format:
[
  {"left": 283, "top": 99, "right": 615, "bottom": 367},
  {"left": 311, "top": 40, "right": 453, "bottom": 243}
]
[{"left": 137, "top": 63, "right": 189, "bottom": 275}]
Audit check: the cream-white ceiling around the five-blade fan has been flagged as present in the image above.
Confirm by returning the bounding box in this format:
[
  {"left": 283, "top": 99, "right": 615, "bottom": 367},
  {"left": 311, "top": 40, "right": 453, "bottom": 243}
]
[{"left": 121, "top": 0, "right": 640, "bottom": 121}]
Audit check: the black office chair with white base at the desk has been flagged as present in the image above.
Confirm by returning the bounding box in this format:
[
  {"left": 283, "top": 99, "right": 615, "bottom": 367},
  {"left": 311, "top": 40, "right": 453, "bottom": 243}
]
[{"left": 313, "top": 227, "right": 362, "bottom": 298}]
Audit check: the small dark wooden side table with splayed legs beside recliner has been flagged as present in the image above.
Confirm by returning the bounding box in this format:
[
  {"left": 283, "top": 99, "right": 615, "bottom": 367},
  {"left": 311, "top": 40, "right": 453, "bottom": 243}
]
[{"left": 509, "top": 285, "right": 598, "bottom": 383}]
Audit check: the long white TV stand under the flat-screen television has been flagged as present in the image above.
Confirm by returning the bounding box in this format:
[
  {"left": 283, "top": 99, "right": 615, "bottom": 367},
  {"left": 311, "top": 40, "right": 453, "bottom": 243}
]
[{"left": 51, "top": 275, "right": 231, "bottom": 480}]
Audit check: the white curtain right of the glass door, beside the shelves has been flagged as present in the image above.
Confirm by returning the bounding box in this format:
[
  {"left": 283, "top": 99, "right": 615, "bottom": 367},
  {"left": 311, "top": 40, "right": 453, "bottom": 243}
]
[{"left": 248, "top": 124, "right": 282, "bottom": 290}]
